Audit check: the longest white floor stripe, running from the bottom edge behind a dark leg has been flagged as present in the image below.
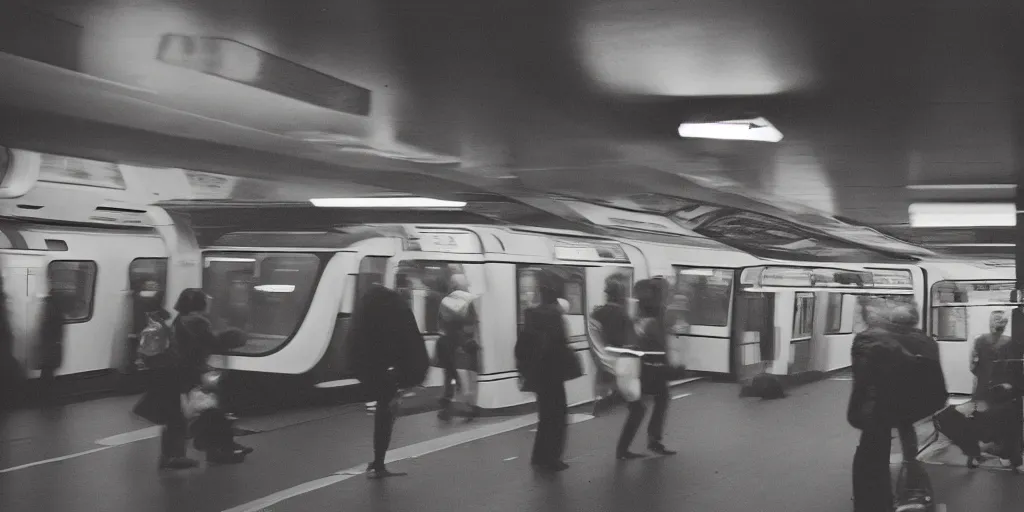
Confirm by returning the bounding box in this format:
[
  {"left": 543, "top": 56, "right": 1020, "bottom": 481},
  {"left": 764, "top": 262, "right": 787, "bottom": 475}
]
[{"left": 224, "top": 414, "right": 537, "bottom": 512}]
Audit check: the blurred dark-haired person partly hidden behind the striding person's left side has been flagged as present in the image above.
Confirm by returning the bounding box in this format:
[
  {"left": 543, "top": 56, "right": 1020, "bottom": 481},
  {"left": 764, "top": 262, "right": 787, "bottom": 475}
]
[{"left": 588, "top": 274, "right": 635, "bottom": 416}]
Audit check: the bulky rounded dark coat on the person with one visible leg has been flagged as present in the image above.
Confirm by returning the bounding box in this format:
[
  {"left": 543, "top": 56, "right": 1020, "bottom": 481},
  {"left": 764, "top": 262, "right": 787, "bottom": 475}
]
[{"left": 346, "top": 285, "right": 430, "bottom": 393}]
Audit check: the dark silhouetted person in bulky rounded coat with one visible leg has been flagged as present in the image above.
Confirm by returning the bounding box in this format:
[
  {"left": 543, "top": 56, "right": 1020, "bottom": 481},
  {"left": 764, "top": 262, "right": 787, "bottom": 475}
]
[{"left": 347, "top": 285, "right": 430, "bottom": 478}]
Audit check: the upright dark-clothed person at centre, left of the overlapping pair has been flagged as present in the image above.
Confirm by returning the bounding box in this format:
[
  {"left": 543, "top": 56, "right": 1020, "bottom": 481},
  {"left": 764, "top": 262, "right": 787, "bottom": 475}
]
[{"left": 515, "top": 270, "right": 582, "bottom": 471}]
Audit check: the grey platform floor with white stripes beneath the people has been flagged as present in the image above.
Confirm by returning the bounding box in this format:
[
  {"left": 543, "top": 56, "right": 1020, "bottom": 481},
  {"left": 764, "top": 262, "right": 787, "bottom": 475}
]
[{"left": 0, "top": 380, "right": 1024, "bottom": 512}]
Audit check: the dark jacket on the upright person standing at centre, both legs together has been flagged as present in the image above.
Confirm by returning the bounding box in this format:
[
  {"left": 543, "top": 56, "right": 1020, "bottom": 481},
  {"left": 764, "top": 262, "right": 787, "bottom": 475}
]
[{"left": 515, "top": 304, "right": 577, "bottom": 390}]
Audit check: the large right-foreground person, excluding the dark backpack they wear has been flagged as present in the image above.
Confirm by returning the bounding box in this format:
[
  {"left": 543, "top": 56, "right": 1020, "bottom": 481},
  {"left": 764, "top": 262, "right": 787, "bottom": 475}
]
[{"left": 847, "top": 297, "right": 939, "bottom": 512}]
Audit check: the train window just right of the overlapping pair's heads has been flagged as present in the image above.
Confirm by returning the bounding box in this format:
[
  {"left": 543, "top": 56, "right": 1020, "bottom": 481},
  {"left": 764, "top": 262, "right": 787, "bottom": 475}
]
[{"left": 668, "top": 267, "right": 734, "bottom": 334}]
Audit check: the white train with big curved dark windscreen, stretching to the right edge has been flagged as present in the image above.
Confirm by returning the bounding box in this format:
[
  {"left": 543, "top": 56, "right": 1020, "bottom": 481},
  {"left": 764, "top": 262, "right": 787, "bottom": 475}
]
[{"left": 165, "top": 197, "right": 1014, "bottom": 409}]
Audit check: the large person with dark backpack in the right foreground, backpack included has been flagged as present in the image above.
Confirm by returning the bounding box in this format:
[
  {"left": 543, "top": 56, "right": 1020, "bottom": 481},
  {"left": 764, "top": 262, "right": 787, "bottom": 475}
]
[{"left": 847, "top": 297, "right": 948, "bottom": 512}]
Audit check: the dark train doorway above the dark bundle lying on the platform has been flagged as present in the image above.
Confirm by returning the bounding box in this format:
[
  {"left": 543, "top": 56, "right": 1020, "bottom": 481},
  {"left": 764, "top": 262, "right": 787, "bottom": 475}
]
[{"left": 732, "top": 292, "right": 776, "bottom": 381}]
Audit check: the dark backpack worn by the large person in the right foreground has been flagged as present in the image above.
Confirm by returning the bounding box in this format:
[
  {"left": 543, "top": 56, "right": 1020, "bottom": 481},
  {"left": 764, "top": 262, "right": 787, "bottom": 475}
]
[{"left": 891, "top": 332, "right": 949, "bottom": 422}]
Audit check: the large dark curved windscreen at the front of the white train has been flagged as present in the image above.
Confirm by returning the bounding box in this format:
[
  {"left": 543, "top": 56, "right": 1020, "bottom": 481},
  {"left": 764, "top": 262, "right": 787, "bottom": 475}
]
[{"left": 203, "top": 252, "right": 323, "bottom": 355}]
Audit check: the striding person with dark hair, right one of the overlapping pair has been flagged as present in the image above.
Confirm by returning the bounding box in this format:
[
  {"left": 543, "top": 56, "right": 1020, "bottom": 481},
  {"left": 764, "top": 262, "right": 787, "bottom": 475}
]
[{"left": 615, "top": 280, "right": 676, "bottom": 460}]
